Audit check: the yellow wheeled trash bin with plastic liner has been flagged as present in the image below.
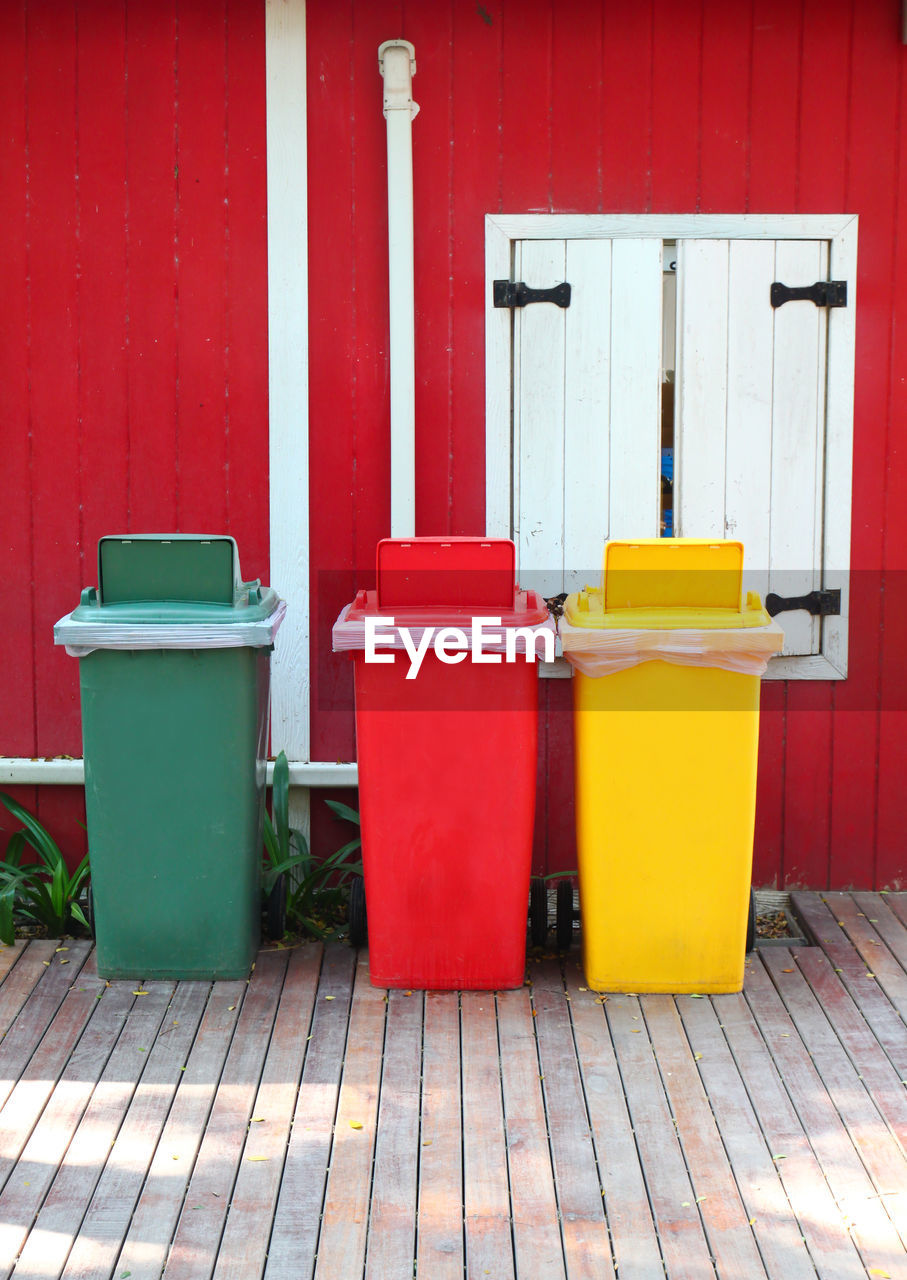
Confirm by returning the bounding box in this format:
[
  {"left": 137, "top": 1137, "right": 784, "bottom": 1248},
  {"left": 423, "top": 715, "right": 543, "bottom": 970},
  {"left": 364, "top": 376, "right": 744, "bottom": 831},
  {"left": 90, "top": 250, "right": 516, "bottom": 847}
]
[{"left": 560, "top": 539, "right": 783, "bottom": 993}]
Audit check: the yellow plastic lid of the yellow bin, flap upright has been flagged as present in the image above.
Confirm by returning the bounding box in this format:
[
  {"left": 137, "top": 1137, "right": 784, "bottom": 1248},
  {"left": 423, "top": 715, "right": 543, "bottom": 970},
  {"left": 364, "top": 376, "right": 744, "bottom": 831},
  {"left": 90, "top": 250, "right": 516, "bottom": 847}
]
[{"left": 564, "top": 538, "right": 769, "bottom": 630}]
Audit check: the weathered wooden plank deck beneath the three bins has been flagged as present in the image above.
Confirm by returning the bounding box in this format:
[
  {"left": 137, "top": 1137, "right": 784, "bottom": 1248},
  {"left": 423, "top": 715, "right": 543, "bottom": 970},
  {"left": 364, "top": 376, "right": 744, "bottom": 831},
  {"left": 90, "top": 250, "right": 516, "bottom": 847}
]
[{"left": 0, "top": 893, "right": 907, "bottom": 1280}]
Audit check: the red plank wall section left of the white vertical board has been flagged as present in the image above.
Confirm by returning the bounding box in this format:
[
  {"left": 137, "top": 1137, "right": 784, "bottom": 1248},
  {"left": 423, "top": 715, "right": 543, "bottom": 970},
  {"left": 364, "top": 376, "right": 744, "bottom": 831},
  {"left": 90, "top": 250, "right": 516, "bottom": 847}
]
[{"left": 0, "top": 0, "right": 269, "bottom": 850}]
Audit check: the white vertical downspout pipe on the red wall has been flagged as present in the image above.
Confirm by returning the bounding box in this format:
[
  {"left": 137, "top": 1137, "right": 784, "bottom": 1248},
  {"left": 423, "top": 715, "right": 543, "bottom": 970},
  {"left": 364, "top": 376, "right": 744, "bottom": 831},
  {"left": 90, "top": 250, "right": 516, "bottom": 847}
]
[{"left": 377, "top": 40, "right": 418, "bottom": 538}]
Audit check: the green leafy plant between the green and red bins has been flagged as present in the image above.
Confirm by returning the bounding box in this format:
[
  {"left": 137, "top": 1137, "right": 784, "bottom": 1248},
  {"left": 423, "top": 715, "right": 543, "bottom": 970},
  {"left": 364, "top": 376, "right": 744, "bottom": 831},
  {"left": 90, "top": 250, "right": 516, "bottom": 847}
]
[{"left": 262, "top": 751, "right": 362, "bottom": 938}]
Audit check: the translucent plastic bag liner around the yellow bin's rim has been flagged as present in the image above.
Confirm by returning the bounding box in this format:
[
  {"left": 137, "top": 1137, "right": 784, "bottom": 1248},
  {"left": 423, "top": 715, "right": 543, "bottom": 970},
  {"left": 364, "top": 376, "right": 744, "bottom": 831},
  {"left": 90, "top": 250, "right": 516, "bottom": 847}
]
[{"left": 558, "top": 618, "right": 784, "bottom": 676}]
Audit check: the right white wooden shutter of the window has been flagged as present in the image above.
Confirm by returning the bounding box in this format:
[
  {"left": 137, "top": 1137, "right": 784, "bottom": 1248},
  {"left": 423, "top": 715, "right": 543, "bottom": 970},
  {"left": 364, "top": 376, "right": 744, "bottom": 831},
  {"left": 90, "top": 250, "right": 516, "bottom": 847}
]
[{"left": 674, "top": 239, "right": 829, "bottom": 655}]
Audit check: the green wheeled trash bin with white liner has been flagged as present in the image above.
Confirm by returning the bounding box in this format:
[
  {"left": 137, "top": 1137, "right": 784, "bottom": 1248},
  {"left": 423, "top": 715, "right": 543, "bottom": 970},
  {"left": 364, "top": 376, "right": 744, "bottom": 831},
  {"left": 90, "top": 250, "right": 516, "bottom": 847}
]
[{"left": 54, "top": 534, "right": 285, "bottom": 980}]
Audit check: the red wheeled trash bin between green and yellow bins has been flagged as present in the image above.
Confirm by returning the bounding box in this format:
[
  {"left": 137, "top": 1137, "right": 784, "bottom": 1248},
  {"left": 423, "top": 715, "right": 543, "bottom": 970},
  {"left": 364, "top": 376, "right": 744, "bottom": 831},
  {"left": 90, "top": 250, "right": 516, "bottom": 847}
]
[{"left": 334, "top": 538, "right": 553, "bottom": 991}]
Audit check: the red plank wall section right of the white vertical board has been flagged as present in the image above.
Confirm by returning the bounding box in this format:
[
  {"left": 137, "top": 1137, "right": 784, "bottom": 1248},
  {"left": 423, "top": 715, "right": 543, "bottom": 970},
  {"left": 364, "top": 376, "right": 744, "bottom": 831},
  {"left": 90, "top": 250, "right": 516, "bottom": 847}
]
[{"left": 308, "top": 0, "right": 907, "bottom": 887}]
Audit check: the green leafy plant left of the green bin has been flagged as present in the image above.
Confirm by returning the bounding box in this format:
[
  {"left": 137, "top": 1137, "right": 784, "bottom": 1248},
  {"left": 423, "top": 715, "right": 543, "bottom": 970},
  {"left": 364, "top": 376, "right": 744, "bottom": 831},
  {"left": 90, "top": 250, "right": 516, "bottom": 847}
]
[{"left": 0, "top": 791, "right": 90, "bottom": 945}]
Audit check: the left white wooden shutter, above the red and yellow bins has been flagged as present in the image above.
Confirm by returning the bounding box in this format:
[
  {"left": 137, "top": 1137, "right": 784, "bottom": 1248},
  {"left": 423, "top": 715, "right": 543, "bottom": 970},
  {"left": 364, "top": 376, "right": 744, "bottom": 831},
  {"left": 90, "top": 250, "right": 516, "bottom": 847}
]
[{"left": 512, "top": 238, "right": 661, "bottom": 595}]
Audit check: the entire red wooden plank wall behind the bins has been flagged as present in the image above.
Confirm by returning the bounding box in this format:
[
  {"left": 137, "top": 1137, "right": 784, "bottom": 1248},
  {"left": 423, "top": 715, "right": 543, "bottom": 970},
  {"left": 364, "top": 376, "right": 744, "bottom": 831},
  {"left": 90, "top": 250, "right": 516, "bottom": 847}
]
[{"left": 0, "top": 0, "right": 907, "bottom": 887}]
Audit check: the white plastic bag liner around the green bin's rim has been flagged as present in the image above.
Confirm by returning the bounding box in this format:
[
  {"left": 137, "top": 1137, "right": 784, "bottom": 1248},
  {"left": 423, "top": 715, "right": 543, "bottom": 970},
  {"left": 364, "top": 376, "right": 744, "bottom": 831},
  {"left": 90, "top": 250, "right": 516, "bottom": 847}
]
[{"left": 54, "top": 600, "right": 287, "bottom": 658}]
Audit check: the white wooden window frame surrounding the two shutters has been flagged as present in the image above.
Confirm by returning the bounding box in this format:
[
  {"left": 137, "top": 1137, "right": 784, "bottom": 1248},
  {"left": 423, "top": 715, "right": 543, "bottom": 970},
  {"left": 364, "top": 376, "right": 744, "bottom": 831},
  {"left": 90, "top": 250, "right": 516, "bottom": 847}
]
[{"left": 485, "top": 214, "right": 858, "bottom": 680}]
